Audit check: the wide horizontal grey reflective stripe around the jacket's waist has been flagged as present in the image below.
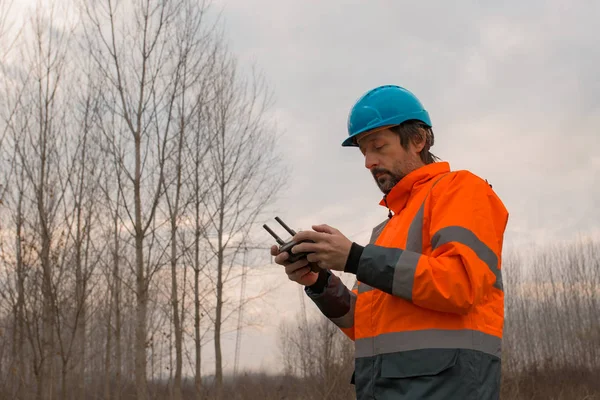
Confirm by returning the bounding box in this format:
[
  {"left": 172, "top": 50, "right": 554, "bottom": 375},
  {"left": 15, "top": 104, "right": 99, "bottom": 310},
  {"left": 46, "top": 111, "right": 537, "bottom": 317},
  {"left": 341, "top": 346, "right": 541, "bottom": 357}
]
[{"left": 355, "top": 329, "right": 502, "bottom": 358}]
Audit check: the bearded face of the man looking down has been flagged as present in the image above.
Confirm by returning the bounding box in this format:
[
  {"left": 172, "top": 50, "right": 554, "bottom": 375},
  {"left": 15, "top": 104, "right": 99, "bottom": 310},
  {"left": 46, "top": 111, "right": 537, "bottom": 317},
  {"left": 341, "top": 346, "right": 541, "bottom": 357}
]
[{"left": 357, "top": 129, "right": 424, "bottom": 194}]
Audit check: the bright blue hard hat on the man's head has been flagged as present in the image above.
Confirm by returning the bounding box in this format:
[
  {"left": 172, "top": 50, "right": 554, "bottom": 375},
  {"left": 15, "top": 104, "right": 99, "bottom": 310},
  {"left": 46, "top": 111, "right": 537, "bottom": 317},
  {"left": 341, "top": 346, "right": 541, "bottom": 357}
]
[{"left": 342, "top": 85, "right": 431, "bottom": 146}]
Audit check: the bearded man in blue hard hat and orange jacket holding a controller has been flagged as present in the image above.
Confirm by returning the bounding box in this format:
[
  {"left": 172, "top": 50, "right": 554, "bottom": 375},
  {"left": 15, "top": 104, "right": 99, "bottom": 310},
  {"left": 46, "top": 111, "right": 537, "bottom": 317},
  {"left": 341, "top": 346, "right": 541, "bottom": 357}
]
[{"left": 271, "top": 85, "right": 508, "bottom": 400}]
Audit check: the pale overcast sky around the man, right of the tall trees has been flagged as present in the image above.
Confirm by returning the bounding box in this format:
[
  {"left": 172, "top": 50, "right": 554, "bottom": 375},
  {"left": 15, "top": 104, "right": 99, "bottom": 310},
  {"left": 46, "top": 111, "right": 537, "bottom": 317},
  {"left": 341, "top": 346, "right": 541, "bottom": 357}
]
[{"left": 8, "top": 0, "right": 600, "bottom": 378}]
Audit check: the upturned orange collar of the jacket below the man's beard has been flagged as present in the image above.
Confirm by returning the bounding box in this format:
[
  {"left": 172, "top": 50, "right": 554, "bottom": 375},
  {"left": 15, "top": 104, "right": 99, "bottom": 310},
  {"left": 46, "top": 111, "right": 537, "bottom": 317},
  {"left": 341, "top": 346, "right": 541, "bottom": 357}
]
[{"left": 379, "top": 161, "right": 450, "bottom": 218}]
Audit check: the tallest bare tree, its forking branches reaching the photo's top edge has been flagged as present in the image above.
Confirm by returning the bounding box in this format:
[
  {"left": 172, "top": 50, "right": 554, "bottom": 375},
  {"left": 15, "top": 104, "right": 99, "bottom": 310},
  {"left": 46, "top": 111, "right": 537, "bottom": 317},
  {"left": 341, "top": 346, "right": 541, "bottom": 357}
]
[{"left": 79, "top": 0, "right": 200, "bottom": 400}]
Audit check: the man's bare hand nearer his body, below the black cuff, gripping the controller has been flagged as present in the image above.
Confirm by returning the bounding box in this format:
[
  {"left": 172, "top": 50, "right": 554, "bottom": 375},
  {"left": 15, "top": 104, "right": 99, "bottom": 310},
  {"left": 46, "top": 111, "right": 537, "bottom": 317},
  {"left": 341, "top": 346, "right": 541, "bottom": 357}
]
[{"left": 291, "top": 225, "right": 352, "bottom": 272}]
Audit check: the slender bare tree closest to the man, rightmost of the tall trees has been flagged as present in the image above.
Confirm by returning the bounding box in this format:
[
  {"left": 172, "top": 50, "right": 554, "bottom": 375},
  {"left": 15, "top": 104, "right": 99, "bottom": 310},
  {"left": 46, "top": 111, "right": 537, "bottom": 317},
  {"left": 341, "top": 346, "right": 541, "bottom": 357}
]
[{"left": 204, "top": 47, "right": 281, "bottom": 398}]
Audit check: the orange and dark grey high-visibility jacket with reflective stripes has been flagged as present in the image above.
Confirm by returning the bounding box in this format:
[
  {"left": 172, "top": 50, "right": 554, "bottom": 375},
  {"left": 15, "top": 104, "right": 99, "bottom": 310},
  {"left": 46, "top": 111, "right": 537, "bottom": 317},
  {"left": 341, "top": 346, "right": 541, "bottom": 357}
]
[{"left": 305, "top": 162, "right": 508, "bottom": 400}]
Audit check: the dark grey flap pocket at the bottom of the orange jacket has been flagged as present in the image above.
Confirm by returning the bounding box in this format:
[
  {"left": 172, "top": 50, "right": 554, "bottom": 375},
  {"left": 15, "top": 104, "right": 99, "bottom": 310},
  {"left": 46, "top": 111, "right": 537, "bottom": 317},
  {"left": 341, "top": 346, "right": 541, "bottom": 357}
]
[{"left": 381, "top": 349, "right": 458, "bottom": 378}]
